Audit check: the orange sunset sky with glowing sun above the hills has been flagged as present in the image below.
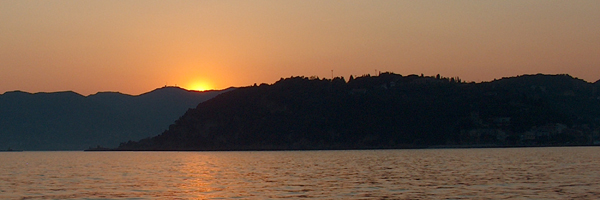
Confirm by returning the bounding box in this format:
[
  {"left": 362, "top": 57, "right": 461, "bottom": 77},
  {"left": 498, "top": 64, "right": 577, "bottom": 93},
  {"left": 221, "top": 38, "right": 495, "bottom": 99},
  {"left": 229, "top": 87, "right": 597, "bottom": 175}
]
[{"left": 0, "top": 0, "right": 600, "bottom": 95}]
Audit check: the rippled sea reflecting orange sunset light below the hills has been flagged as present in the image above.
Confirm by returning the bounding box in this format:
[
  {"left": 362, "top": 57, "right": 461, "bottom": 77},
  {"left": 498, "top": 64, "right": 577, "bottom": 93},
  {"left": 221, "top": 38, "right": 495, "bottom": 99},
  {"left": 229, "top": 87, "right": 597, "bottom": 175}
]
[{"left": 0, "top": 147, "right": 600, "bottom": 199}]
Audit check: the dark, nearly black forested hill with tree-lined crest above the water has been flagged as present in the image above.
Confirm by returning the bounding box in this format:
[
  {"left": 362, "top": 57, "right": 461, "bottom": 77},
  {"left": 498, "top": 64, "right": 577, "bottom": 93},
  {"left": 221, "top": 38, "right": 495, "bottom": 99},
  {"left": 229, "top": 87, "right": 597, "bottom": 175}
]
[{"left": 116, "top": 73, "right": 600, "bottom": 150}]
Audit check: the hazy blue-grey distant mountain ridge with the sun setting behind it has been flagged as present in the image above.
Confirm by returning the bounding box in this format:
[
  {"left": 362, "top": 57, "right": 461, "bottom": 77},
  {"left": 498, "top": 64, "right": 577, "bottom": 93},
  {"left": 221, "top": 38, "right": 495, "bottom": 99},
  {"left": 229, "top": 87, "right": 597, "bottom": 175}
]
[{"left": 0, "top": 87, "right": 232, "bottom": 150}]
